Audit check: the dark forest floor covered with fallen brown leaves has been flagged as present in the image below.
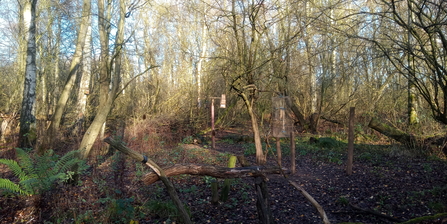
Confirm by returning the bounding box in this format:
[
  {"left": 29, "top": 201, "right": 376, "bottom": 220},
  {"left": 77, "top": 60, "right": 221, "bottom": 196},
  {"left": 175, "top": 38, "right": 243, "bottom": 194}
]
[{"left": 0, "top": 127, "right": 447, "bottom": 224}]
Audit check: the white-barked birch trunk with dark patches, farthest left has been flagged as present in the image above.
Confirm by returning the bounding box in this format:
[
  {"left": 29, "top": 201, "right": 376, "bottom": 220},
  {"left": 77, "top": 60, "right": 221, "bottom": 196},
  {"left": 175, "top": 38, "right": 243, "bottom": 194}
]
[{"left": 18, "top": 0, "right": 37, "bottom": 148}]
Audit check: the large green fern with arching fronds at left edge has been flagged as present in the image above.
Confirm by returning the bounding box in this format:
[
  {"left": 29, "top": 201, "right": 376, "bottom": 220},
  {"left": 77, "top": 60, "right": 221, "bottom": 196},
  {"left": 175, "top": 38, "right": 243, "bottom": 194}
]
[{"left": 0, "top": 148, "right": 87, "bottom": 195}]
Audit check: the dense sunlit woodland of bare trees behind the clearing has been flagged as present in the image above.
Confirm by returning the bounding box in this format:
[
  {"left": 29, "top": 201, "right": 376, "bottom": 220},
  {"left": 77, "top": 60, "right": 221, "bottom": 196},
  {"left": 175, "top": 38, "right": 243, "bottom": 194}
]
[{"left": 0, "top": 0, "right": 447, "bottom": 221}]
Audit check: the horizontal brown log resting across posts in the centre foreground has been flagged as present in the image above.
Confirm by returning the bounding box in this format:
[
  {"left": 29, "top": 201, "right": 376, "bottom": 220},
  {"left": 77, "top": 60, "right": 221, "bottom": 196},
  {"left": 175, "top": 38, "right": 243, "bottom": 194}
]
[{"left": 142, "top": 164, "right": 281, "bottom": 185}]
